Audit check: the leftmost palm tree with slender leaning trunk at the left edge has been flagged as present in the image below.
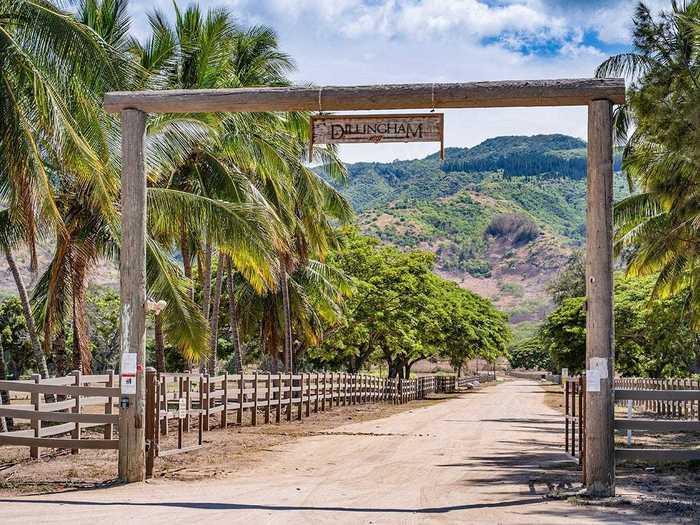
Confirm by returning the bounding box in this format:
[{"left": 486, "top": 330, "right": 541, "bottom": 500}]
[{"left": 0, "top": 0, "right": 132, "bottom": 377}]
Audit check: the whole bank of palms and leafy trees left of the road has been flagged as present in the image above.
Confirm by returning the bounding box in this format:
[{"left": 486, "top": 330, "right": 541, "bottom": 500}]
[{"left": 0, "top": 0, "right": 510, "bottom": 378}]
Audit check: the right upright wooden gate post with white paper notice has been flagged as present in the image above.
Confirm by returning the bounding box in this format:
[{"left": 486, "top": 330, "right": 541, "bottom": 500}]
[{"left": 582, "top": 100, "right": 615, "bottom": 497}]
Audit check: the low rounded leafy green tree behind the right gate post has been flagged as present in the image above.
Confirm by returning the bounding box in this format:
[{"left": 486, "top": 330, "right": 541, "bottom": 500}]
[{"left": 539, "top": 276, "right": 700, "bottom": 377}]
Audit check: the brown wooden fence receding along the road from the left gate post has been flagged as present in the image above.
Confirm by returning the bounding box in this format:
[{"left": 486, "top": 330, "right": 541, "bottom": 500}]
[{"left": 146, "top": 369, "right": 460, "bottom": 476}]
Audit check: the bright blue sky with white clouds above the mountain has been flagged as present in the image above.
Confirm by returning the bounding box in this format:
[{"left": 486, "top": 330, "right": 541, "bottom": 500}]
[{"left": 131, "top": 0, "right": 670, "bottom": 162}]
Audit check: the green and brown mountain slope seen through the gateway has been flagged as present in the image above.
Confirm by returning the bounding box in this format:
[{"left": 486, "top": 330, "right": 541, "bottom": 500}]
[{"left": 342, "top": 135, "right": 627, "bottom": 332}]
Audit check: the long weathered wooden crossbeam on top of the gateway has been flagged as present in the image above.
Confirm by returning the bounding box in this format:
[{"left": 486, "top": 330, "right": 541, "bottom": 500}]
[{"left": 104, "top": 78, "right": 625, "bottom": 113}]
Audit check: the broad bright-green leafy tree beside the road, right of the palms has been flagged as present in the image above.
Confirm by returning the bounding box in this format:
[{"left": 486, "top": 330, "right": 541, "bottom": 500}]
[{"left": 311, "top": 230, "right": 509, "bottom": 377}]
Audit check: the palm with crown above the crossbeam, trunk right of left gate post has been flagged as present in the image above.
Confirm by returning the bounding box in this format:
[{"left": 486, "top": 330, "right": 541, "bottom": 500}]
[{"left": 132, "top": 6, "right": 300, "bottom": 368}]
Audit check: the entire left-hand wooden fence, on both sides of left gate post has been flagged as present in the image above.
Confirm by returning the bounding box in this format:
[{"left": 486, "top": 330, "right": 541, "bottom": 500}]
[{"left": 0, "top": 369, "right": 495, "bottom": 470}]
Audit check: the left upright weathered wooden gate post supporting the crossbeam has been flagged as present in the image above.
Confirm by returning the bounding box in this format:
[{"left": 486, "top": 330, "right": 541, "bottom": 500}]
[{"left": 119, "top": 109, "right": 146, "bottom": 482}]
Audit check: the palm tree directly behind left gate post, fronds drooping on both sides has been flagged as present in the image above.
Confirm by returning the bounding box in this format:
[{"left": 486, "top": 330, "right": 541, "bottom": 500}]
[{"left": 28, "top": 1, "right": 270, "bottom": 371}]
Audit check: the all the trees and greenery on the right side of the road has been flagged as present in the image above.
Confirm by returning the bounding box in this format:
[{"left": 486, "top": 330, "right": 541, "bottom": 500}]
[{"left": 511, "top": 1, "right": 700, "bottom": 377}]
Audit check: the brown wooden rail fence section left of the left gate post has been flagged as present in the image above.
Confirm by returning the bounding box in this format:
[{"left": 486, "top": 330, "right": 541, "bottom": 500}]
[{"left": 0, "top": 372, "right": 119, "bottom": 458}]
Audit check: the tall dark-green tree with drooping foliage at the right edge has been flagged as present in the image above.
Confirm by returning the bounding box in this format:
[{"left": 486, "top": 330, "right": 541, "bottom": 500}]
[{"left": 597, "top": 0, "right": 700, "bottom": 323}]
